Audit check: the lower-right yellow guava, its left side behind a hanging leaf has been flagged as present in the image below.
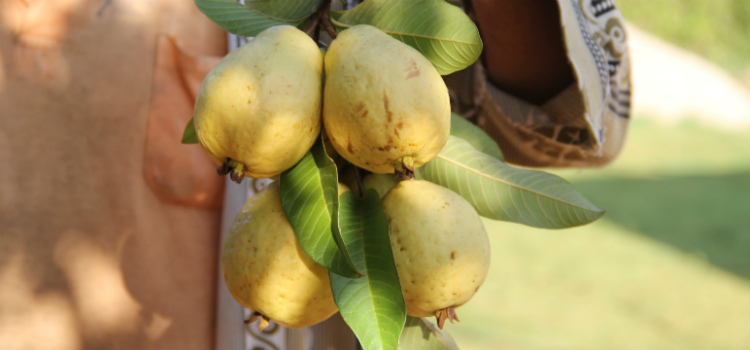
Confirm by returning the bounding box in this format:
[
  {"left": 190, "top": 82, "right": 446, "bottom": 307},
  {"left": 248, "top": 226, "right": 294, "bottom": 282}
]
[{"left": 383, "top": 180, "right": 490, "bottom": 328}]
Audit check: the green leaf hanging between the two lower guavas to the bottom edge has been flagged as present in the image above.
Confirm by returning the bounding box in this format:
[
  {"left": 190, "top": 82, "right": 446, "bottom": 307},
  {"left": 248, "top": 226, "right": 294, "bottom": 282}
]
[{"left": 330, "top": 189, "right": 406, "bottom": 350}]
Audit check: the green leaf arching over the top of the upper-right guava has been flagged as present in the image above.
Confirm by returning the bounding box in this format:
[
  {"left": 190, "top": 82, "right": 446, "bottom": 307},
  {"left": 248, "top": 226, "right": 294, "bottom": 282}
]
[{"left": 331, "top": 0, "right": 482, "bottom": 75}]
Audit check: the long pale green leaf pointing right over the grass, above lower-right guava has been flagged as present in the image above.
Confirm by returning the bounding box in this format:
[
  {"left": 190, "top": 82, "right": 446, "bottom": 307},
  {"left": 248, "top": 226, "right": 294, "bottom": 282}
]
[{"left": 419, "top": 136, "right": 604, "bottom": 228}]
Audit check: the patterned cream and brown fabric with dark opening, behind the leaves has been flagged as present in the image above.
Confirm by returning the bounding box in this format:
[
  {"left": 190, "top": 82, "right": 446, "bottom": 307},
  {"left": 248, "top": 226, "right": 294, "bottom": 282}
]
[{"left": 445, "top": 0, "right": 630, "bottom": 167}]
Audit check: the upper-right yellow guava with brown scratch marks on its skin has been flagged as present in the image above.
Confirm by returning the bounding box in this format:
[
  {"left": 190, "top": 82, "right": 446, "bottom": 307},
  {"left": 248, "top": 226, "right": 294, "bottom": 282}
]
[{"left": 323, "top": 25, "right": 450, "bottom": 174}]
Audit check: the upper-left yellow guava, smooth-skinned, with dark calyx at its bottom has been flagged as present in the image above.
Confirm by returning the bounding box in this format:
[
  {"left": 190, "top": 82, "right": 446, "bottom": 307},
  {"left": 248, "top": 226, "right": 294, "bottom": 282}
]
[{"left": 193, "top": 25, "right": 323, "bottom": 182}]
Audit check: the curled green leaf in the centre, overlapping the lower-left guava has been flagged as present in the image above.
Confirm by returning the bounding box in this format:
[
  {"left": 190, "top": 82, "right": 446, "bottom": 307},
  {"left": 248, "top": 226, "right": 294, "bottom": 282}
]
[{"left": 279, "top": 139, "right": 359, "bottom": 277}]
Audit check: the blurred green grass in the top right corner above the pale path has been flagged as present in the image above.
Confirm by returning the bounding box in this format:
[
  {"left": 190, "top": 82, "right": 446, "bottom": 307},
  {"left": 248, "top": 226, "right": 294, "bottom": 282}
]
[{"left": 617, "top": 0, "right": 750, "bottom": 75}]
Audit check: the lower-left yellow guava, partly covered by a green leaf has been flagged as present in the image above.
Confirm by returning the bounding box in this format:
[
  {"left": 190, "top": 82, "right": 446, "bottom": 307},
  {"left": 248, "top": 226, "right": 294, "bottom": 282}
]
[{"left": 221, "top": 183, "right": 338, "bottom": 328}]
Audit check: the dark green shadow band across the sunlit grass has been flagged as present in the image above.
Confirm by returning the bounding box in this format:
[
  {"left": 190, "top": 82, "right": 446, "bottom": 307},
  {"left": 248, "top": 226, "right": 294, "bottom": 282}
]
[{"left": 572, "top": 172, "right": 750, "bottom": 280}]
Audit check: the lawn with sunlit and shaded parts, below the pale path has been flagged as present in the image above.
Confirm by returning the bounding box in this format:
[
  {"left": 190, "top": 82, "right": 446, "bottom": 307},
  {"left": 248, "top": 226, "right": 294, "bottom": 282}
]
[{"left": 446, "top": 118, "right": 750, "bottom": 350}]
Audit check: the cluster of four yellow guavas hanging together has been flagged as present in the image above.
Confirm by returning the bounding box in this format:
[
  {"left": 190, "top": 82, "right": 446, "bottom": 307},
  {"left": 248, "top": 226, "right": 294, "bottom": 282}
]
[{"left": 193, "top": 25, "right": 489, "bottom": 327}]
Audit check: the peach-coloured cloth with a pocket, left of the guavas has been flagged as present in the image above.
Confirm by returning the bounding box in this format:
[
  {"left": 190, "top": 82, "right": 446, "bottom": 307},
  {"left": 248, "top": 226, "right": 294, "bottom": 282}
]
[{"left": 0, "top": 0, "right": 226, "bottom": 349}]
